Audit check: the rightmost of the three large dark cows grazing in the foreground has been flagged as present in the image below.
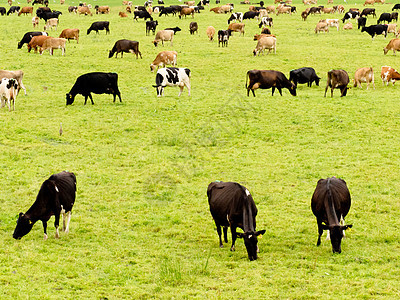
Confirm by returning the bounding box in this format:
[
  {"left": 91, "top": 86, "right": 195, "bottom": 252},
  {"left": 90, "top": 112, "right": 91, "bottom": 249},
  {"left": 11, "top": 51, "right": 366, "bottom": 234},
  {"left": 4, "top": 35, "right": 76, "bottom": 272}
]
[{"left": 311, "top": 177, "right": 353, "bottom": 253}]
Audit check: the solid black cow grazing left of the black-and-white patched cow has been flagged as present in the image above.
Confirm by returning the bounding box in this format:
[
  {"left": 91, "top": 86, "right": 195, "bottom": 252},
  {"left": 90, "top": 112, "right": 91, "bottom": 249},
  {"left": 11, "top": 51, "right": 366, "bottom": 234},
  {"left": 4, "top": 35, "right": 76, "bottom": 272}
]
[{"left": 67, "top": 72, "right": 122, "bottom": 105}]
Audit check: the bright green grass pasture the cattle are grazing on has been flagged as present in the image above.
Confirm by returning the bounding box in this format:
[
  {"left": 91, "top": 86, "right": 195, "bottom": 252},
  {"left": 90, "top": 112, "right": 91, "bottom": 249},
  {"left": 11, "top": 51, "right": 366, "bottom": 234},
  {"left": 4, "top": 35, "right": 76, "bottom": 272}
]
[{"left": 0, "top": 0, "right": 400, "bottom": 299}]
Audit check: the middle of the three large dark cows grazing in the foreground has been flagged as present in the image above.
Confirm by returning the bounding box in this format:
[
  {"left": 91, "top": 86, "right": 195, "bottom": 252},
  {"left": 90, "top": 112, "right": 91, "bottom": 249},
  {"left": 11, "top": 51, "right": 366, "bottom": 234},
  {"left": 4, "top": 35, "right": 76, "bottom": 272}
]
[{"left": 207, "top": 182, "right": 265, "bottom": 261}]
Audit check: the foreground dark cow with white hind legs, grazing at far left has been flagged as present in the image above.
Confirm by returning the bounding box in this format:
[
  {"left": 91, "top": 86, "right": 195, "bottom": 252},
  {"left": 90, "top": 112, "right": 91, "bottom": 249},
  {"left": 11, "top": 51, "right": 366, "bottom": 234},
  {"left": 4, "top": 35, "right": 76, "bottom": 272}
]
[{"left": 13, "top": 171, "right": 76, "bottom": 240}]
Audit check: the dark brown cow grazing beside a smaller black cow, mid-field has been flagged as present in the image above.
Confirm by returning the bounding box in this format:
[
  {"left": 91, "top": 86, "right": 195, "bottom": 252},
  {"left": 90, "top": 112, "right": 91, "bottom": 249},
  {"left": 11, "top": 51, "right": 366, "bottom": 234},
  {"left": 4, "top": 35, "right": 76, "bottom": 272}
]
[{"left": 246, "top": 70, "right": 296, "bottom": 97}]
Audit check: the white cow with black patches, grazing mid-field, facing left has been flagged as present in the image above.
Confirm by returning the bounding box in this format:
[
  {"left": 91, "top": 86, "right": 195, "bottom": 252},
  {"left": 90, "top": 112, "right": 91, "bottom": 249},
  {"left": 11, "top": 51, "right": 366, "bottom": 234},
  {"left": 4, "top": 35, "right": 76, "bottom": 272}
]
[{"left": 153, "top": 67, "right": 190, "bottom": 97}]
